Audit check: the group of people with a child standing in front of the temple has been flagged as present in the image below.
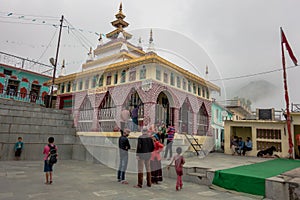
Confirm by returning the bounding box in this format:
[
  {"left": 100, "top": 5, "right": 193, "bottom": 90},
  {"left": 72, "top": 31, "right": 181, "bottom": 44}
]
[{"left": 117, "top": 123, "right": 185, "bottom": 191}]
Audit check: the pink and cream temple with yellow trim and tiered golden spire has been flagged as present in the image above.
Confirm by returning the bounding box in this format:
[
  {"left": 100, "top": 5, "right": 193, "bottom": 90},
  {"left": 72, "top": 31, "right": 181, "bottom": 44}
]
[{"left": 55, "top": 4, "right": 220, "bottom": 135}]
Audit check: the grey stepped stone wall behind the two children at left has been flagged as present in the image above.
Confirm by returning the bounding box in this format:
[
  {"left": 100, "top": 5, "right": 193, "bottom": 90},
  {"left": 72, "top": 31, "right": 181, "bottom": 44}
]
[{"left": 0, "top": 99, "right": 77, "bottom": 160}]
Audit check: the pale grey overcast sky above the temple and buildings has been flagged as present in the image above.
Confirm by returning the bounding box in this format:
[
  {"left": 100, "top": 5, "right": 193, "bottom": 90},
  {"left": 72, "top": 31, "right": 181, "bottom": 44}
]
[{"left": 0, "top": 0, "right": 300, "bottom": 109}]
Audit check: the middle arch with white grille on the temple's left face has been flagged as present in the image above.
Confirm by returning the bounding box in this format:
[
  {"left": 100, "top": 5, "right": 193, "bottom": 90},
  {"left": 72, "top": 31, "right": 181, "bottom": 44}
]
[{"left": 98, "top": 92, "right": 117, "bottom": 132}]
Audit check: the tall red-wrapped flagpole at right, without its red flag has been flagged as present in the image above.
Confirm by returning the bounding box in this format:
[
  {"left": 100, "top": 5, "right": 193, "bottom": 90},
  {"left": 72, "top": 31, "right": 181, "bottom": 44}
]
[{"left": 280, "top": 27, "right": 294, "bottom": 158}]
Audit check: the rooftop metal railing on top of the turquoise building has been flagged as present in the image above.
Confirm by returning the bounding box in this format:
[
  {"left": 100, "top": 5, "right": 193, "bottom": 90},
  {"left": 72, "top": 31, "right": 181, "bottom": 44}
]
[{"left": 0, "top": 51, "right": 53, "bottom": 76}]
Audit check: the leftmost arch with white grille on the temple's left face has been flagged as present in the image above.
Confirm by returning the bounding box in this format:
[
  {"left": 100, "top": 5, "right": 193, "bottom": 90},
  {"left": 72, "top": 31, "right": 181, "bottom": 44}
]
[{"left": 77, "top": 97, "right": 94, "bottom": 132}]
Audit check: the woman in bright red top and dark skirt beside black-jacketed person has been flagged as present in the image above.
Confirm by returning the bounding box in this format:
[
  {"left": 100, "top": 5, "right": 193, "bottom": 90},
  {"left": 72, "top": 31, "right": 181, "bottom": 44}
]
[{"left": 150, "top": 134, "right": 164, "bottom": 184}]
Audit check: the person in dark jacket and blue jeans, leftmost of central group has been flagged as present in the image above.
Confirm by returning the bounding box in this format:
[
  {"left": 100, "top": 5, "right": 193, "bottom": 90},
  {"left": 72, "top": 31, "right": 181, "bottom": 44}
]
[{"left": 117, "top": 129, "right": 130, "bottom": 184}]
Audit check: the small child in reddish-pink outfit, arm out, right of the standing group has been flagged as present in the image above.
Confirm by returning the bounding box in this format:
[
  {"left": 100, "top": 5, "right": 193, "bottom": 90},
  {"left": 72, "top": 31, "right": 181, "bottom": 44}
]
[{"left": 167, "top": 147, "right": 185, "bottom": 191}]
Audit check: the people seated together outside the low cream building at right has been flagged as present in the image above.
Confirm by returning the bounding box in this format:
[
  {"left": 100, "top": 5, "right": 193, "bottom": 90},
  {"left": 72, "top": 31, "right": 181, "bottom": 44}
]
[{"left": 230, "top": 136, "right": 252, "bottom": 156}]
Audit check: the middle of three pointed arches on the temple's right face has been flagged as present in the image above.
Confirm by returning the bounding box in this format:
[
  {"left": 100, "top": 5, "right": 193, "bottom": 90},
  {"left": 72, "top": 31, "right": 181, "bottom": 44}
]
[{"left": 179, "top": 99, "right": 193, "bottom": 134}]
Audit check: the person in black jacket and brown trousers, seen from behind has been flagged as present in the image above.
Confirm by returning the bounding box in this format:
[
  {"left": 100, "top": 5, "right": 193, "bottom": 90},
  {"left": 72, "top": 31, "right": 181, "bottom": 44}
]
[{"left": 134, "top": 127, "right": 154, "bottom": 188}]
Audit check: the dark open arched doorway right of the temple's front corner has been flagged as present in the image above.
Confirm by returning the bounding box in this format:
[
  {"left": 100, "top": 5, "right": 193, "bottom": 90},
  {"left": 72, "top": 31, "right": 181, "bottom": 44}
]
[{"left": 155, "top": 92, "right": 174, "bottom": 125}]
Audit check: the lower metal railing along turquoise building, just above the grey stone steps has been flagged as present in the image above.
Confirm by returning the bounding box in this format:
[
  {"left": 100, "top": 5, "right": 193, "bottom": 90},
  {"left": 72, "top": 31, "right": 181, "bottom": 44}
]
[{"left": 0, "top": 89, "right": 46, "bottom": 105}]
